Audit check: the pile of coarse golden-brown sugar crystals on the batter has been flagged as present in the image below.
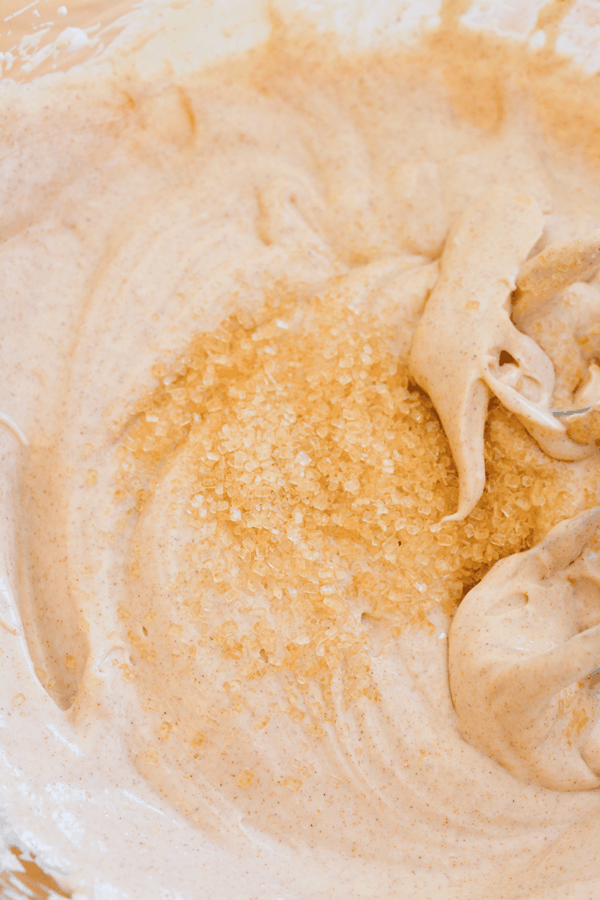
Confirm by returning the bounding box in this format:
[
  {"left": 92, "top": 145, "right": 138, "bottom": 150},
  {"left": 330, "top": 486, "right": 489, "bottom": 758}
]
[{"left": 118, "top": 290, "right": 592, "bottom": 717}]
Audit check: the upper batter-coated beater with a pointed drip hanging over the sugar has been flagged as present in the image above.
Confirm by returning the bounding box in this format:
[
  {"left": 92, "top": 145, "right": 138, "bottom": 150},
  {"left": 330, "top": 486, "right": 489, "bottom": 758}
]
[{"left": 410, "top": 189, "right": 600, "bottom": 519}]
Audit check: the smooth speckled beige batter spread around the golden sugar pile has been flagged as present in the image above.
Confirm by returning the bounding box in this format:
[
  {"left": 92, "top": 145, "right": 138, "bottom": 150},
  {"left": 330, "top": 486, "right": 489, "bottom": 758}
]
[{"left": 0, "top": 1, "right": 600, "bottom": 900}]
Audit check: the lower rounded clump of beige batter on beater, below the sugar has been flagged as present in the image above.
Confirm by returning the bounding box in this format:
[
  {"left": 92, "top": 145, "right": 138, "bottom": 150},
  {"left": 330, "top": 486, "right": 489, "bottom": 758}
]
[{"left": 448, "top": 509, "right": 600, "bottom": 791}]
